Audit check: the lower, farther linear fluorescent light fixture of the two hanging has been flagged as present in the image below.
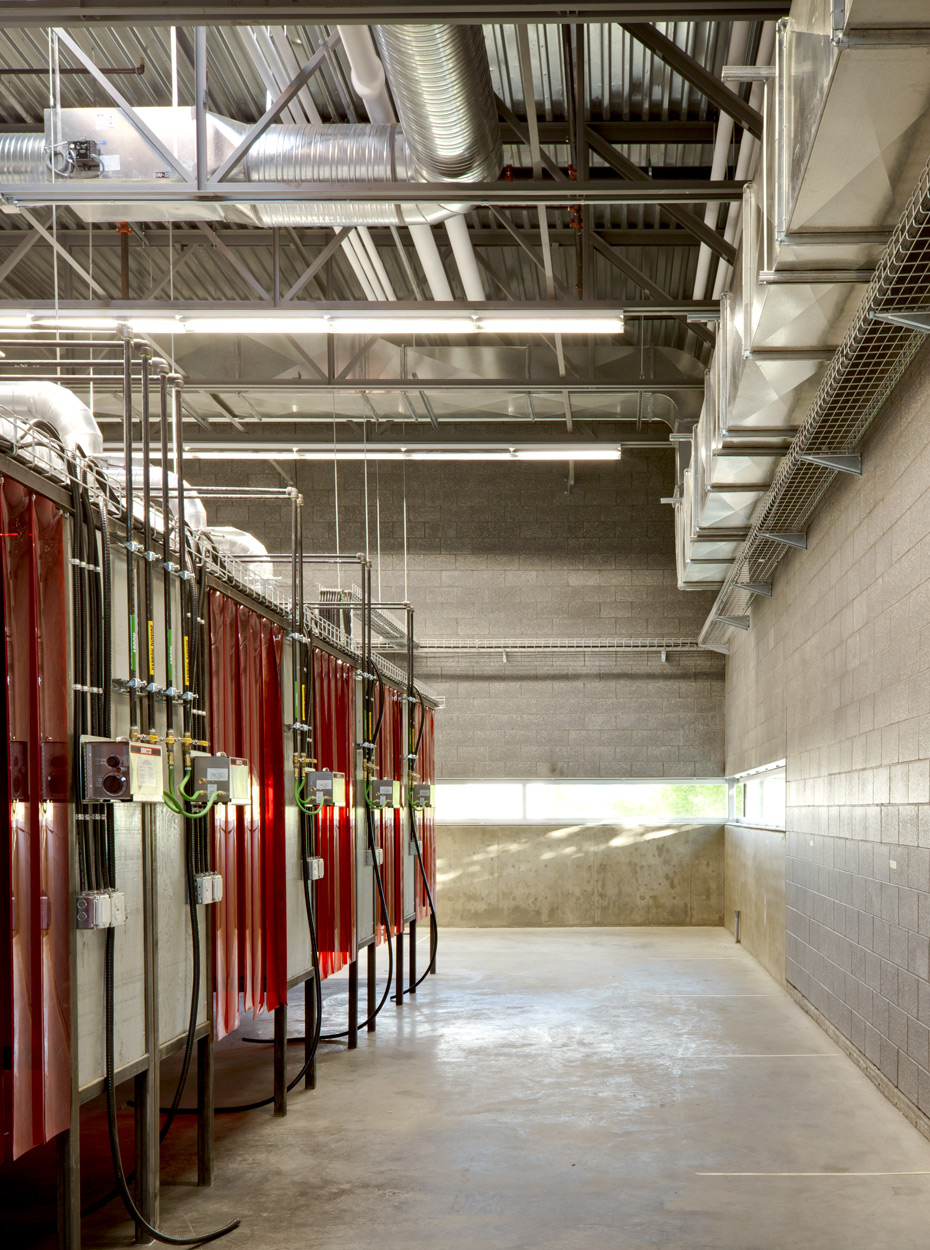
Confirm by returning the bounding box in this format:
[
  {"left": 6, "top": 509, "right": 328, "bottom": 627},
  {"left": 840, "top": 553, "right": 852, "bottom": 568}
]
[{"left": 177, "top": 443, "right": 621, "bottom": 464}]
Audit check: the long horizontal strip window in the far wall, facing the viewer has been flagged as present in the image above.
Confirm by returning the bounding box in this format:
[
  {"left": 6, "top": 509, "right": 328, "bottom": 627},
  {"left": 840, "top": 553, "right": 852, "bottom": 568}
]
[{"left": 436, "top": 778, "right": 726, "bottom": 825}]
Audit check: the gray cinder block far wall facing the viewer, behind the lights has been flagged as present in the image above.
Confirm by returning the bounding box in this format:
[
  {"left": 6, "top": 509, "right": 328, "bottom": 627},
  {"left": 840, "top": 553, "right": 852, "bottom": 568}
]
[{"left": 189, "top": 445, "right": 724, "bottom": 924}]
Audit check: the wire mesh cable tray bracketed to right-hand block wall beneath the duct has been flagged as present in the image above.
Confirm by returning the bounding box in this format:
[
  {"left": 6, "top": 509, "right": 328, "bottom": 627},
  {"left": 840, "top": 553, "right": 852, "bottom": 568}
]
[{"left": 700, "top": 151, "right": 930, "bottom": 651}]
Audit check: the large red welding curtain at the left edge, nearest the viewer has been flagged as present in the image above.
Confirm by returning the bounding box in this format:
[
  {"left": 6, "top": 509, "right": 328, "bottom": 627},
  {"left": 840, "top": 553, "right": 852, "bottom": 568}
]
[{"left": 0, "top": 480, "right": 71, "bottom": 1160}]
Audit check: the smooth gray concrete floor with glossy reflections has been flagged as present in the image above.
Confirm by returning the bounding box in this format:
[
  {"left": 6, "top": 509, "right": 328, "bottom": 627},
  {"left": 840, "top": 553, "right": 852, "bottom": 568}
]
[{"left": 85, "top": 929, "right": 930, "bottom": 1250}]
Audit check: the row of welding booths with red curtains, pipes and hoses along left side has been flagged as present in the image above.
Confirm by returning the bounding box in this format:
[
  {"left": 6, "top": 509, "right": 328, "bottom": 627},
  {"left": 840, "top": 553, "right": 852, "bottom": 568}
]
[{"left": 0, "top": 357, "right": 436, "bottom": 1246}]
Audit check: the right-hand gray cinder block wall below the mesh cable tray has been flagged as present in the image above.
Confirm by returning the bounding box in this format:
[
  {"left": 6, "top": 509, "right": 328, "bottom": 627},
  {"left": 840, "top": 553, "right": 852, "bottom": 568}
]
[{"left": 726, "top": 353, "right": 930, "bottom": 1114}]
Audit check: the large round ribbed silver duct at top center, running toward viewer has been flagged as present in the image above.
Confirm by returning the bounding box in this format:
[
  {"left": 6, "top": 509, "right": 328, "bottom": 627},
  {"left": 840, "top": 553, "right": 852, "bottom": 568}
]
[{"left": 374, "top": 25, "right": 504, "bottom": 183}]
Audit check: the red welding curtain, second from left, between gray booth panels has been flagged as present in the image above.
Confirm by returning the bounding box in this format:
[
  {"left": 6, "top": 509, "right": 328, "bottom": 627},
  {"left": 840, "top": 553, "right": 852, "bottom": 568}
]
[{"left": 210, "top": 591, "right": 288, "bottom": 1038}]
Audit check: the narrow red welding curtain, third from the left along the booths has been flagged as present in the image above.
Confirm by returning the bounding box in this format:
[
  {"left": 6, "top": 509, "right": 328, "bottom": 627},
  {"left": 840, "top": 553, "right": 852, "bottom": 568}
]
[{"left": 314, "top": 651, "right": 356, "bottom": 976}]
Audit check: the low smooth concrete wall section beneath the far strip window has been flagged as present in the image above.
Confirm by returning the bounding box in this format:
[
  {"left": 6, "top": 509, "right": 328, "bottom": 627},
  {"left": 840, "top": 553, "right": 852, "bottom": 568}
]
[{"left": 438, "top": 824, "right": 724, "bottom": 928}]
